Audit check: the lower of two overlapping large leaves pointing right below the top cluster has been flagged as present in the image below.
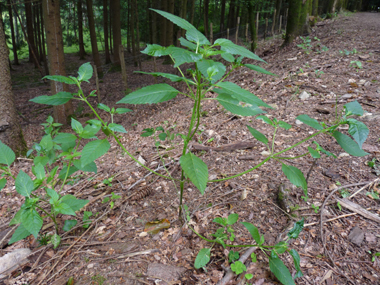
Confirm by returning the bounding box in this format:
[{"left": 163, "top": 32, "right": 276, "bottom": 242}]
[{"left": 215, "top": 90, "right": 265, "bottom": 116}]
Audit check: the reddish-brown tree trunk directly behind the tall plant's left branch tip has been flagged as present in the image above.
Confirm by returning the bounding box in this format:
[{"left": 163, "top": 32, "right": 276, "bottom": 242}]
[{"left": 42, "top": 0, "right": 74, "bottom": 124}]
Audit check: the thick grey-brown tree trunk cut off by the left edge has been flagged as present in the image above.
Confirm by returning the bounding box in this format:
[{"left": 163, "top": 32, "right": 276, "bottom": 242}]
[{"left": 0, "top": 12, "right": 26, "bottom": 153}]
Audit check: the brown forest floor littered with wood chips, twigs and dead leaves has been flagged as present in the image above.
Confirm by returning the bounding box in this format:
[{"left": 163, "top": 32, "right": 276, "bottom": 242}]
[{"left": 0, "top": 13, "right": 380, "bottom": 285}]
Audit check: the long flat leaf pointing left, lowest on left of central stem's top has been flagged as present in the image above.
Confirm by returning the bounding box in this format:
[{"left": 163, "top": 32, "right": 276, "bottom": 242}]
[{"left": 117, "top": 83, "right": 178, "bottom": 104}]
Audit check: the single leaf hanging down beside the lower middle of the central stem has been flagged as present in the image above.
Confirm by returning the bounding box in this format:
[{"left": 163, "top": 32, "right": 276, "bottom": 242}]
[{"left": 179, "top": 152, "right": 208, "bottom": 195}]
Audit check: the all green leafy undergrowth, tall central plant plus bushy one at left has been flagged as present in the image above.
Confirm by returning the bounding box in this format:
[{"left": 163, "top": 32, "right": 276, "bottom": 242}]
[{"left": 0, "top": 10, "right": 369, "bottom": 284}]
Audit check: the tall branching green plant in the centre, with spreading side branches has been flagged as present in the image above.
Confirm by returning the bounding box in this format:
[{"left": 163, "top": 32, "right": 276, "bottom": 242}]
[{"left": 14, "top": 10, "right": 368, "bottom": 284}]
